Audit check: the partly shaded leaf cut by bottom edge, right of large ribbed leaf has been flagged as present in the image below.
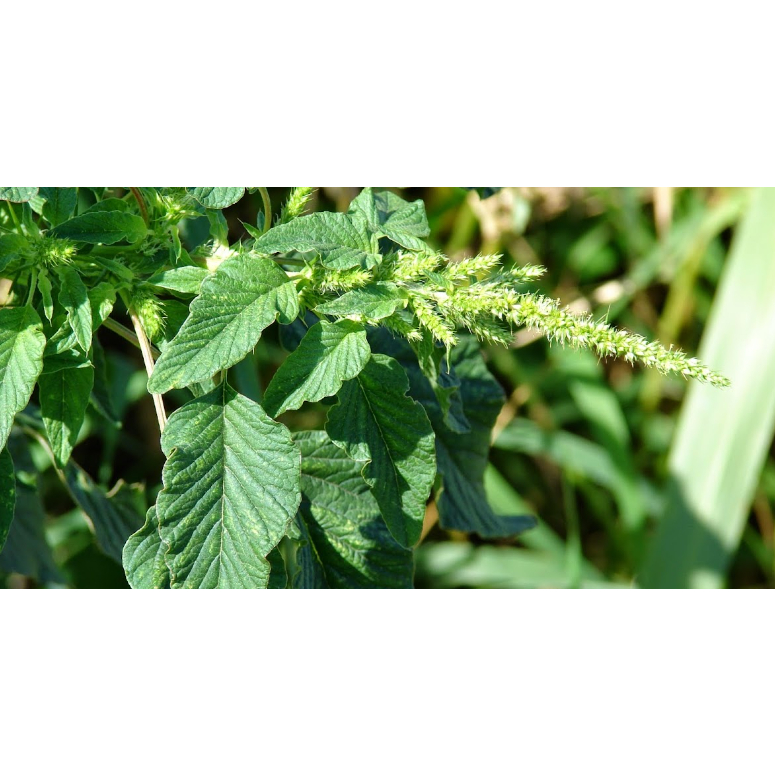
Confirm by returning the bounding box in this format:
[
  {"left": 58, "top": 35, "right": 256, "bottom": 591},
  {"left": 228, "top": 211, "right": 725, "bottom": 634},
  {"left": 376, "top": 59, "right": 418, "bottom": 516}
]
[{"left": 294, "top": 431, "right": 413, "bottom": 589}]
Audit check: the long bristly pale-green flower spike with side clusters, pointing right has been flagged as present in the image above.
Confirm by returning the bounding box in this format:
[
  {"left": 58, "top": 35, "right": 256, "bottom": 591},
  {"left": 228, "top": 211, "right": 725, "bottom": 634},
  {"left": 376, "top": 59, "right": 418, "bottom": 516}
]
[{"left": 300, "top": 246, "right": 729, "bottom": 387}]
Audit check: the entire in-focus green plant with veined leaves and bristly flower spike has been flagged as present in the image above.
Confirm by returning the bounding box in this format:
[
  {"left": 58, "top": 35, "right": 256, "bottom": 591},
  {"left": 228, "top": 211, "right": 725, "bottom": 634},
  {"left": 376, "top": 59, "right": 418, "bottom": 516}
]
[{"left": 0, "top": 188, "right": 727, "bottom": 588}]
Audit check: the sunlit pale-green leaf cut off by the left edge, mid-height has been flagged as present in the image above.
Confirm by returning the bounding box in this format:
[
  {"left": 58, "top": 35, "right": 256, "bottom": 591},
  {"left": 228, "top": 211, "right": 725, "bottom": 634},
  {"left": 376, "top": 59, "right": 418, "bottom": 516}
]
[{"left": 0, "top": 307, "right": 46, "bottom": 448}]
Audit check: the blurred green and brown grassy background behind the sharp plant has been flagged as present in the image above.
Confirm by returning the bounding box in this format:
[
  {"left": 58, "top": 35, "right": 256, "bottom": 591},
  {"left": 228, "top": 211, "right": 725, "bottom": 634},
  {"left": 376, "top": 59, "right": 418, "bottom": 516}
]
[{"left": 0, "top": 188, "right": 775, "bottom": 588}]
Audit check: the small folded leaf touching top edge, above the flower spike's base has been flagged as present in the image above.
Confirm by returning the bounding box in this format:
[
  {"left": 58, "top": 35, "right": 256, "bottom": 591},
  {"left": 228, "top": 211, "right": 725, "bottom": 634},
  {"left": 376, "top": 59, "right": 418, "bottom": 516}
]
[{"left": 348, "top": 188, "right": 431, "bottom": 250}]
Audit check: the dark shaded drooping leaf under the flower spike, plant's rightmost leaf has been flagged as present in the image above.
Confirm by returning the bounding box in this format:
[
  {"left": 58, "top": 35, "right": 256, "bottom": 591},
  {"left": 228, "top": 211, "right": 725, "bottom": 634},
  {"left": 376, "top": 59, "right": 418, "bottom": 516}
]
[{"left": 371, "top": 334, "right": 535, "bottom": 538}]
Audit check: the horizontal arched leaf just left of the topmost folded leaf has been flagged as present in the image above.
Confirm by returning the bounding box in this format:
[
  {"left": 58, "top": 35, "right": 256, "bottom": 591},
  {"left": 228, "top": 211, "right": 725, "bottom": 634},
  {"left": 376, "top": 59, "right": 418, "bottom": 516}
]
[{"left": 254, "top": 213, "right": 381, "bottom": 269}]
